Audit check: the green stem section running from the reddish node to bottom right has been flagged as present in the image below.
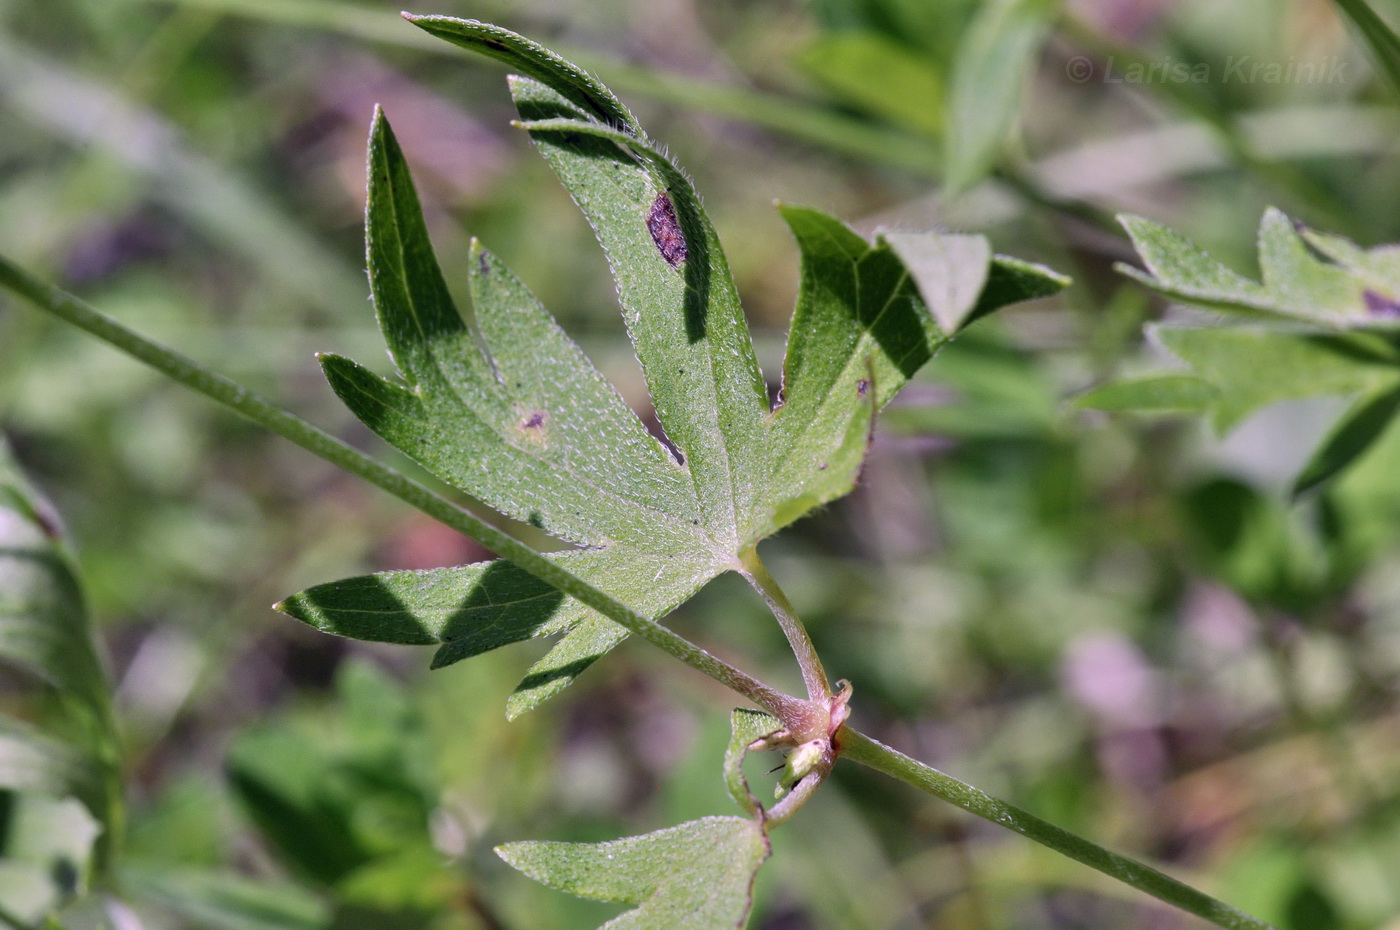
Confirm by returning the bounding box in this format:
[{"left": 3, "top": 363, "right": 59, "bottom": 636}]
[{"left": 836, "top": 727, "right": 1274, "bottom": 930}]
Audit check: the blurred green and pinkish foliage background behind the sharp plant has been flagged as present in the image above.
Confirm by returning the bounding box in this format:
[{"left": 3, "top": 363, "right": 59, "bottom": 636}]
[{"left": 0, "top": 0, "right": 1400, "bottom": 930}]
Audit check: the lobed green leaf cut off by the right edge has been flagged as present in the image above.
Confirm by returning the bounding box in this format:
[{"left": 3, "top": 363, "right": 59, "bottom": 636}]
[{"left": 1092, "top": 209, "right": 1400, "bottom": 493}]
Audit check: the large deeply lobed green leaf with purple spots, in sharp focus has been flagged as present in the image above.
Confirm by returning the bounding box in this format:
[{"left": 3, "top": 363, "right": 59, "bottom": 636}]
[{"left": 277, "top": 17, "right": 1065, "bottom": 716}]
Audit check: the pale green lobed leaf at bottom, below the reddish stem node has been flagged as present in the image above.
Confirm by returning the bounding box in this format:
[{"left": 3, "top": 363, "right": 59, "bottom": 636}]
[{"left": 496, "top": 817, "right": 769, "bottom": 930}]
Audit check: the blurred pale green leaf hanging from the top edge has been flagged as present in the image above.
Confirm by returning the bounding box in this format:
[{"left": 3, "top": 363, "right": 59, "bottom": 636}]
[{"left": 945, "top": 0, "right": 1056, "bottom": 193}]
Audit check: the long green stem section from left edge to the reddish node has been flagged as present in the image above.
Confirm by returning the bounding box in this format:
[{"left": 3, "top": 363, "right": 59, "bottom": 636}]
[{"left": 0, "top": 256, "right": 806, "bottom": 720}]
